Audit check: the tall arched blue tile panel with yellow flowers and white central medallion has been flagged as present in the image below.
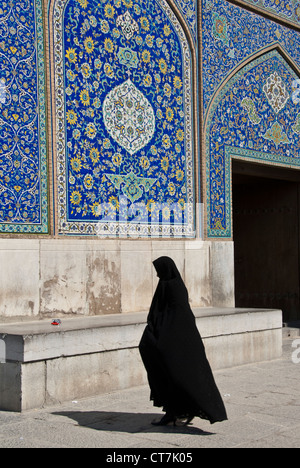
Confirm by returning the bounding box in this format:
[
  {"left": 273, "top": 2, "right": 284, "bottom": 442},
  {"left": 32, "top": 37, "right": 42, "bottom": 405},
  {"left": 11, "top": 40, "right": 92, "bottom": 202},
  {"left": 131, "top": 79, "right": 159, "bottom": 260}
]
[{"left": 53, "top": 0, "right": 195, "bottom": 237}]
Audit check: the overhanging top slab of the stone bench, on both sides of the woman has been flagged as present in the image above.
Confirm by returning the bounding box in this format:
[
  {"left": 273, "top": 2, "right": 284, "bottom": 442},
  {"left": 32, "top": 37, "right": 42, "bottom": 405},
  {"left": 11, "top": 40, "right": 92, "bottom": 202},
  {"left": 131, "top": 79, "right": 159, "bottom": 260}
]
[{"left": 0, "top": 308, "right": 282, "bottom": 363}]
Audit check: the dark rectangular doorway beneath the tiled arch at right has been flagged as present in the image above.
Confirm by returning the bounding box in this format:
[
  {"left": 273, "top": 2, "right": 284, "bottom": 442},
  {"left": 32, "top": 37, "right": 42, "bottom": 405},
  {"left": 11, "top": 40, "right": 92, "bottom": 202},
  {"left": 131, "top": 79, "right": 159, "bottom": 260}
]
[{"left": 232, "top": 161, "right": 300, "bottom": 322}]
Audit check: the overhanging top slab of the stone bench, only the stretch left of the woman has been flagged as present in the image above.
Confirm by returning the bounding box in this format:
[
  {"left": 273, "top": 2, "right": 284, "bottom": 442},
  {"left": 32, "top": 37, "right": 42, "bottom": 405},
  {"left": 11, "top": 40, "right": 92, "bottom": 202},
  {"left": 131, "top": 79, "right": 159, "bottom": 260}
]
[{"left": 0, "top": 313, "right": 147, "bottom": 363}]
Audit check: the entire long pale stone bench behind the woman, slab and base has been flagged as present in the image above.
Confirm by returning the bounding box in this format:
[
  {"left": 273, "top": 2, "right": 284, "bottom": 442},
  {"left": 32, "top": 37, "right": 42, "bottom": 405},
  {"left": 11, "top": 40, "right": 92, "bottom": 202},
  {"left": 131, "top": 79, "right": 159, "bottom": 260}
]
[{"left": 0, "top": 308, "right": 282, "bottom": 411}]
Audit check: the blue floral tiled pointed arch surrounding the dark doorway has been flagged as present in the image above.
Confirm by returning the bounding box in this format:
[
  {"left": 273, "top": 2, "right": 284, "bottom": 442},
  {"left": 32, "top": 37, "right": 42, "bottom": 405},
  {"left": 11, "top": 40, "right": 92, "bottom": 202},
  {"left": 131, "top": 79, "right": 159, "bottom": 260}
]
[{"left": 204, "top": 43, "right": 300, "bottom": 239}]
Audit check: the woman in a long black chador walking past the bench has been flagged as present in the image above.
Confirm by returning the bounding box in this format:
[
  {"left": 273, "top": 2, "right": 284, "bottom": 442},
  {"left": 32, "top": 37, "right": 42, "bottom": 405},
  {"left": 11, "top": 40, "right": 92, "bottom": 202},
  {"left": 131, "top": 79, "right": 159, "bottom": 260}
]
[{"left": 139, "top": 257, "right": 227, "bottom": 425}]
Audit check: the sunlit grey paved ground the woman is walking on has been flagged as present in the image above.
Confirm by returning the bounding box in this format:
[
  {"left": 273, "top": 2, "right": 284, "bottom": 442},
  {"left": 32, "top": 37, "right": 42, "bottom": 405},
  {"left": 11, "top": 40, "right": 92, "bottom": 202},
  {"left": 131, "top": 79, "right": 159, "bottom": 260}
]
[{"left": 0, "top": 337, "right": 300, "bottom": 453}]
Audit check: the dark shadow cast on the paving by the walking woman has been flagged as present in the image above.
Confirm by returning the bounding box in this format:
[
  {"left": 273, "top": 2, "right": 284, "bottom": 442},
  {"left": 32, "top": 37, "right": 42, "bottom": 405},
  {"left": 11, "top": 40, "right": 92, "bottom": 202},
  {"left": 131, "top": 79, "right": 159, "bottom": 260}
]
[{"left": 52, "top": 411, "right": 214, "bottom": 436}]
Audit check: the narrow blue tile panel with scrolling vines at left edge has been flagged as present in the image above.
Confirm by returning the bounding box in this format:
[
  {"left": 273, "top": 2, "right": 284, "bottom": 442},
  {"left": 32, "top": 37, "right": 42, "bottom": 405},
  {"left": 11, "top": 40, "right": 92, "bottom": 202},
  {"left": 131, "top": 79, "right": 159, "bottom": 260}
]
[{"left": 0, "top": 0, "right": 48, "bottom": 234}]
